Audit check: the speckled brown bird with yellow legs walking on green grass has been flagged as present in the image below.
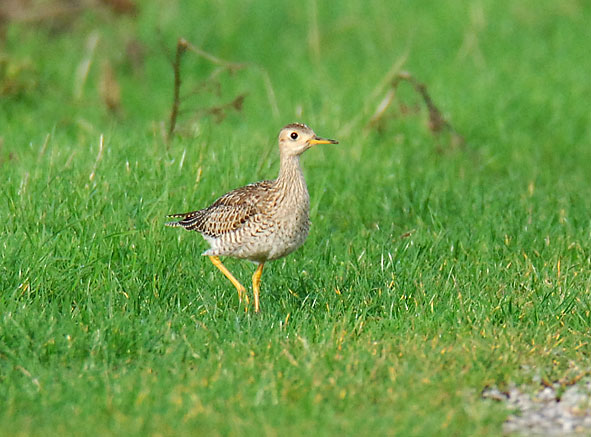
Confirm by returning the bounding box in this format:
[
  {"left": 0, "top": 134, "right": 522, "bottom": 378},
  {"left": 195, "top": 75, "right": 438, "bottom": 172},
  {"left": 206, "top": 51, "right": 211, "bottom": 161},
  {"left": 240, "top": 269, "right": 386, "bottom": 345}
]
[{"left": 165, "top": 123, "right": 338, "bottom": 313}]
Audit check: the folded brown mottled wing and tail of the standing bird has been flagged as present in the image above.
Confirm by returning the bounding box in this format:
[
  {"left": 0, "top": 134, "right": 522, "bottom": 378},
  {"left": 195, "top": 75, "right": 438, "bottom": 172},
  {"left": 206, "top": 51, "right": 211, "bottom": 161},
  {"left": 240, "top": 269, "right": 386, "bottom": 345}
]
[{"left": 166, "top": 181, "right": 272, "bottom": 237}]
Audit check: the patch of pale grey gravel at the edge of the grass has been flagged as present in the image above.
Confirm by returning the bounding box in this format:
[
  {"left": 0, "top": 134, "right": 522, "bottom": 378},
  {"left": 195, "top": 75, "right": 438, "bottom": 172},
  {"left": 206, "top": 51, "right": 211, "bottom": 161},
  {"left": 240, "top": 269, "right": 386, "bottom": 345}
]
[{"left": 482, "top": 381, "right": 591, "bottom": 436}]
